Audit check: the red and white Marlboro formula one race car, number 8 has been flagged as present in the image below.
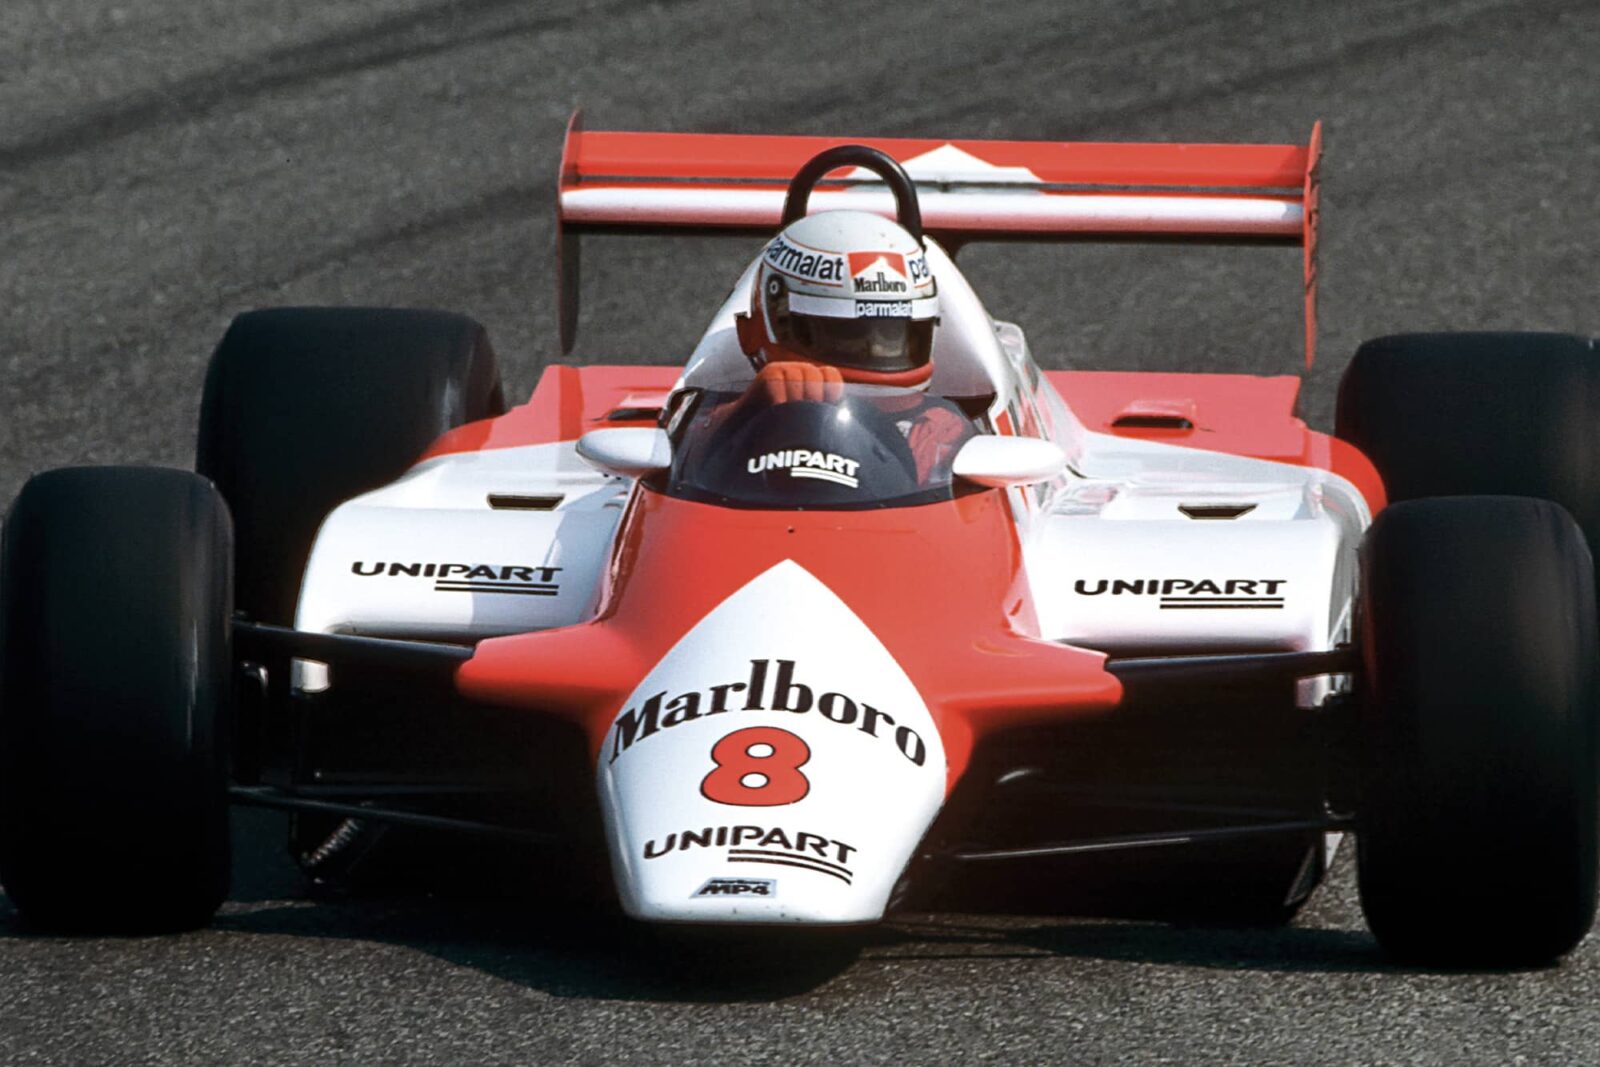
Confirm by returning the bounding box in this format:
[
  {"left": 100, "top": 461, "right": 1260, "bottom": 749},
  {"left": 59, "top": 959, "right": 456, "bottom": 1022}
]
[{"left": 0, "top": 122, "right": 1600, "bottom": 965}]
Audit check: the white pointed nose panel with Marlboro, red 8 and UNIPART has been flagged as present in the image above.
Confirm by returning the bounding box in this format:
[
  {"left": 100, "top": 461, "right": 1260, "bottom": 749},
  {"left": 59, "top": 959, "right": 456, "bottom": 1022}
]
[{"left": 598, "top": 561, "right": 946, "bottom": 923}]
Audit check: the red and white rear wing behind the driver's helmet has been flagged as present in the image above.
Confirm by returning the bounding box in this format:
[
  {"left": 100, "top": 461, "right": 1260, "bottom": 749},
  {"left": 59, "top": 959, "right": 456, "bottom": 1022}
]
[{"left": 555, "top": 112, "right": 1322, "bottom": 366}]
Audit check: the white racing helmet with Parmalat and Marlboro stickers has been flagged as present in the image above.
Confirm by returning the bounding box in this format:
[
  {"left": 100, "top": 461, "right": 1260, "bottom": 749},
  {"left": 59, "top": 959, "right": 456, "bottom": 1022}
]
[{"left": 739, "top": 211, "right": 939, "bottom": 386}]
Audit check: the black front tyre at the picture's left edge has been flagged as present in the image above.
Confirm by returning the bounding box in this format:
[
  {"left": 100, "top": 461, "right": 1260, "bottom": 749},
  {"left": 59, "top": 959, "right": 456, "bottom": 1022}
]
[{"left": 0, "top": 467, "right": 232, "bottom": 931}]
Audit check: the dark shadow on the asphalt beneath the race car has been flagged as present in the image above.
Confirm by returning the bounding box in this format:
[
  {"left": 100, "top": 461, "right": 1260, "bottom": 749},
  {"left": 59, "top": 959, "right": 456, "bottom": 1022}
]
[{"left": 0, "top": 819, "right": 1555, "bottom": 1003}]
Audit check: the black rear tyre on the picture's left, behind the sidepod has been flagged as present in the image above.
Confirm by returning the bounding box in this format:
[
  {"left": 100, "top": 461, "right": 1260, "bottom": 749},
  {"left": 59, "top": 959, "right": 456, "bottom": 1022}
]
[{"left": 195, "top": 307, "right": 506, "bottom": 625}]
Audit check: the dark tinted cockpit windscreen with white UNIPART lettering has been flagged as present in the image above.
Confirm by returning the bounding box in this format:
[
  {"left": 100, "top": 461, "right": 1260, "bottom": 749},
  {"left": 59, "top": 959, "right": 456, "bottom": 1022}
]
[{"left": 666, "top": 384, "right": 976, "bottom": 510}]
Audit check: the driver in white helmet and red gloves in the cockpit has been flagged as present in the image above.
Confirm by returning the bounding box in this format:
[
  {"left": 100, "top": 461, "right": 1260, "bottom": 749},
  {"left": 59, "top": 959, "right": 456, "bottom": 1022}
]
[{"left": 738, "top": 211, "right": 970, "bottom": 480}]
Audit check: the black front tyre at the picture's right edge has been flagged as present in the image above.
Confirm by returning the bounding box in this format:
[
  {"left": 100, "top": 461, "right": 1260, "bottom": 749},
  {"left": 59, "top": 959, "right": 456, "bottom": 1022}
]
[{"left": 1358, "top": 498, "right": 1600, "bottom": 966}]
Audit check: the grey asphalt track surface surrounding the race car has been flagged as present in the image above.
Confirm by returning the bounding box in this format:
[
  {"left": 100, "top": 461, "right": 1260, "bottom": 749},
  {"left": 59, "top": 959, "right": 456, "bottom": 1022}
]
[{"left": 0, "top": 0, "right": 1600, "bottom": 1064}]
